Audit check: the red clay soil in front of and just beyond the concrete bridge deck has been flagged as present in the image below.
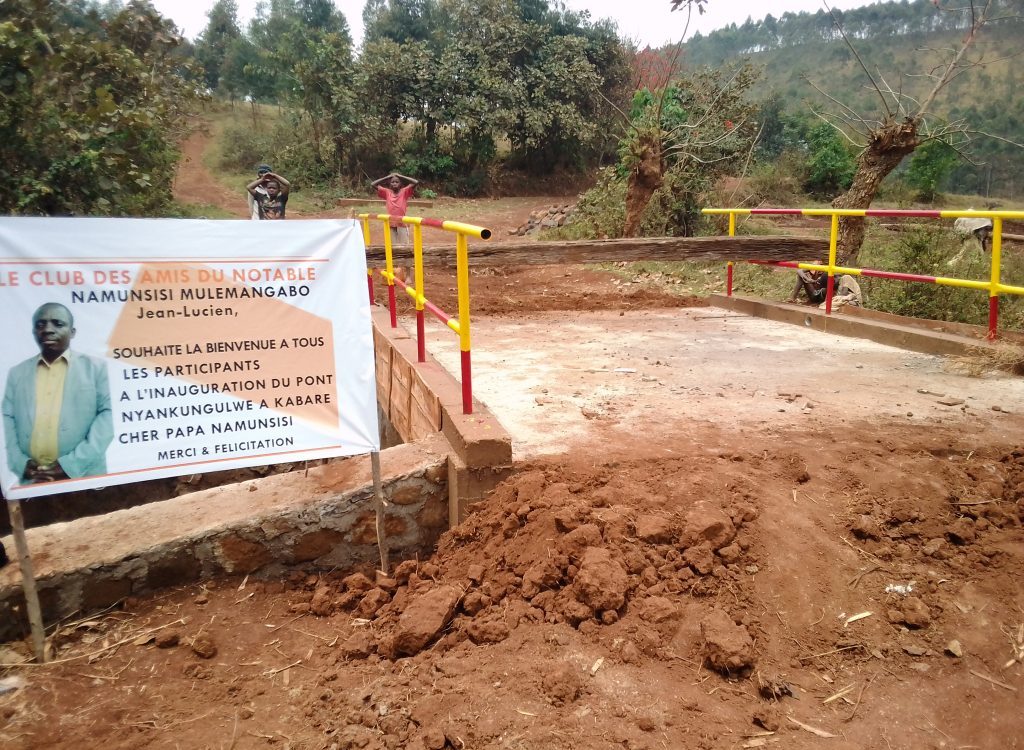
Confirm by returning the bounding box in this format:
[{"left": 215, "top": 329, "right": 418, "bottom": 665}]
[{"left": 0, "top": 119, "right": 1024, "bottom": 750}]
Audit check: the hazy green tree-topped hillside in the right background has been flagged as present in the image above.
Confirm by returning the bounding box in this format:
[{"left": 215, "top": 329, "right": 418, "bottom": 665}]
[{"left": 659, "top": 0, "right": 1024, "bottom": 199}]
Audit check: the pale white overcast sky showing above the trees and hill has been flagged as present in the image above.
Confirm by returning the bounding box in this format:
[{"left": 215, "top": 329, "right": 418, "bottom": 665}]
[{"left": 152, "top": 0, "right": 884, "bottom": 47}]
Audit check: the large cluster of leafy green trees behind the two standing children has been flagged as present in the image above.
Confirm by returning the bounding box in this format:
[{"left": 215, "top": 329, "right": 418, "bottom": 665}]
[{"left": 209, "top": 0, "right": 628, "bottom": 194}]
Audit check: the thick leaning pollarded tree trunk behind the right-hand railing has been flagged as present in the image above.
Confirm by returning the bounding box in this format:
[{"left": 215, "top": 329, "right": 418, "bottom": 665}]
[{"left": 833, "top": 118, "right": 921, "bottom": 265}]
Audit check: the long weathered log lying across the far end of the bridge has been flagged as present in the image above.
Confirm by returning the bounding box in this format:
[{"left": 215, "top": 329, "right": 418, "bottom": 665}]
[{"left": 367, "top": 236, "right": 828, "bottom": 267}]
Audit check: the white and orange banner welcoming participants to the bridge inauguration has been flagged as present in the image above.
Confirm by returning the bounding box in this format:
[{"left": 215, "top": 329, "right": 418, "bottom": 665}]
[{"left": 0, "top": 217, "right": 380, "bottom": 498}]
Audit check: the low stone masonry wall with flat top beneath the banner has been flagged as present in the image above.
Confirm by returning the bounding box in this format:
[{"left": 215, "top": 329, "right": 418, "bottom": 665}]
[{"left": 0, "top": 436, "right": 449, "bottom": 640}]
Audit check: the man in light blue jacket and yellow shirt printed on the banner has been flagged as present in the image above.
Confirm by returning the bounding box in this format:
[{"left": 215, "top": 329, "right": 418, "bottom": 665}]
[{"left": 3, "top": 302, "right": 114, "bottom": 485}]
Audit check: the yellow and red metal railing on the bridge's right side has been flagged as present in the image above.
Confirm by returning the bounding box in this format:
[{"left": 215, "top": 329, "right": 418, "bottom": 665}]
[{"left": 703, "top": 208, "right": 1024, "bottom": 339}]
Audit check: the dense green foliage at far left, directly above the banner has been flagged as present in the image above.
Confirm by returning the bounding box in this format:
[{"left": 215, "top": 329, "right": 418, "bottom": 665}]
[{"left": 0, "top": 0, "right": 196, "bottom": 215}]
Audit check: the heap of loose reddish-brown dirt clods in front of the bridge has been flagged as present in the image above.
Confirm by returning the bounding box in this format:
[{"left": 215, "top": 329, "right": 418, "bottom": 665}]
[{"left": 301, "top": 465, "right": 758, "bottom": 671}]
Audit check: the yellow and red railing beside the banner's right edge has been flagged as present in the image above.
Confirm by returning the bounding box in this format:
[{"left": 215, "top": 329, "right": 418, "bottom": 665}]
[{"left": 358, "top": 213, "right": 490, "bottom": 414}]
